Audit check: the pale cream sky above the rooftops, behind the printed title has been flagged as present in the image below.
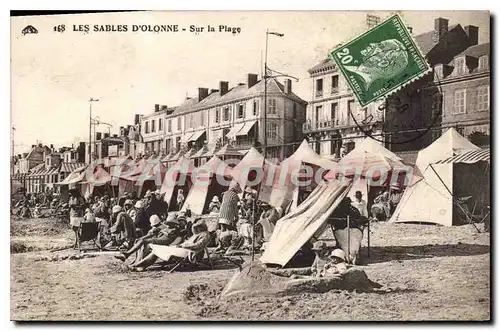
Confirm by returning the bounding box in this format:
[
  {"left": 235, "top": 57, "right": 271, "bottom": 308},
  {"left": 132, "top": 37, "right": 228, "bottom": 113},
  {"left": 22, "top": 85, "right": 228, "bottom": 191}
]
[{"left": 11, "top": 11, "right": 490, "bottom": 154}]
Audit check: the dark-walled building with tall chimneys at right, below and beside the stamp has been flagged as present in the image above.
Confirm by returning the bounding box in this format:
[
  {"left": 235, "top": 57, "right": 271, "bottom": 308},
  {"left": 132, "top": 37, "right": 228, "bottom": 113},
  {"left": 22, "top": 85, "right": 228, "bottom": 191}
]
[{"left": 384, "top": 17, "right": 489, "bottom": 151}]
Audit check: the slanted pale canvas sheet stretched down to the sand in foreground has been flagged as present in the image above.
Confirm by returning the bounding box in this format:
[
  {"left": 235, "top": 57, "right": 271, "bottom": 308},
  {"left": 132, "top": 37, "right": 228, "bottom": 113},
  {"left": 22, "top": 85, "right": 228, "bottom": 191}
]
[{"left": 260, "top": 180, "right": 351, "bottom": 266}]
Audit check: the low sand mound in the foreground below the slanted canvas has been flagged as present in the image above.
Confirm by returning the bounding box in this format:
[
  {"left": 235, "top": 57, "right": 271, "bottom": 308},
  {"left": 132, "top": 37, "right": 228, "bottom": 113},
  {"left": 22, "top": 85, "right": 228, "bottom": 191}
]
[{"left": 221, "top": 261, "right": 382, "bottom": 297}]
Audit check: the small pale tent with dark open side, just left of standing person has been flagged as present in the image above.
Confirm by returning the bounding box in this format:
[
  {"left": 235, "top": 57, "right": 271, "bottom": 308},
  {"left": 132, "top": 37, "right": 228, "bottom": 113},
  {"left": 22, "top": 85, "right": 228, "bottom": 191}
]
[{"left": 181, "top": 155, "right": 231, "bottom": 215}]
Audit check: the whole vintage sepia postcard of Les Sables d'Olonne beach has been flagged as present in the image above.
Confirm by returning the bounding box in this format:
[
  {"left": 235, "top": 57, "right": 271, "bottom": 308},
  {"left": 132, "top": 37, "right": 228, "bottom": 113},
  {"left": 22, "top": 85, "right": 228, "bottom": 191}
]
[{"left": 10, "top": 11, "right": 492, "bottom": 322}]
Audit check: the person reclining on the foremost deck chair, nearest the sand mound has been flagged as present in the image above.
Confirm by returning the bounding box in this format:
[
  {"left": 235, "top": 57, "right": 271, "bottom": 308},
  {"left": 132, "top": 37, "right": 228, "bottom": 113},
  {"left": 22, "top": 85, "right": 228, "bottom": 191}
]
[{"left": 127, "top": 219, "right": 210, "bottom": 271}]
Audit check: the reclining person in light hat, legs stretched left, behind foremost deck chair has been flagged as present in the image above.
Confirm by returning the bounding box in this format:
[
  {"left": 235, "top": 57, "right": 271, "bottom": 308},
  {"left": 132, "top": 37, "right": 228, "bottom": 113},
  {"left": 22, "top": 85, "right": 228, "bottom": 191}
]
[{"left": 115, "top": 215, "right": 182, "bottom": 261}]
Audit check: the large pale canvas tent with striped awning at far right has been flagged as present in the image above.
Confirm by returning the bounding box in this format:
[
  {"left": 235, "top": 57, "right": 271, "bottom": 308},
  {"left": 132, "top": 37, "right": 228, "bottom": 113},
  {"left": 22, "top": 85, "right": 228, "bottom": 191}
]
[{"left": 389, "top": 130, "right": 490, "bottom": 226}]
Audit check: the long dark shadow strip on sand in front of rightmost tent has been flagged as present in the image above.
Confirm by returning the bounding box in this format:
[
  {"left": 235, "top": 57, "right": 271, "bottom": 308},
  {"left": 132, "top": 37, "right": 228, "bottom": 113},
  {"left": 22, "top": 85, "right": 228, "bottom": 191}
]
[{"left": 361, "top": 244, "right": 491, "bottom": 264}]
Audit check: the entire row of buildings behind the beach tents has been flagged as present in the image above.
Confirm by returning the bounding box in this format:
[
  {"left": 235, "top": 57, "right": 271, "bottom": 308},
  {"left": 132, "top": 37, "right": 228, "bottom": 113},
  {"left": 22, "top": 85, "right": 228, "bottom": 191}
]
[{"left": 10, "top": 14, "right": 490, "bottom": 195}]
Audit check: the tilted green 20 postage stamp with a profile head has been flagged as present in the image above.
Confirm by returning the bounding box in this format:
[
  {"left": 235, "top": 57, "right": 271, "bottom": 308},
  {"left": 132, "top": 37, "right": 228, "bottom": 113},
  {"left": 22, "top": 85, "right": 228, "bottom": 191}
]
[{"left": 330, "top": 14, "right": 430, "bottom": 107}]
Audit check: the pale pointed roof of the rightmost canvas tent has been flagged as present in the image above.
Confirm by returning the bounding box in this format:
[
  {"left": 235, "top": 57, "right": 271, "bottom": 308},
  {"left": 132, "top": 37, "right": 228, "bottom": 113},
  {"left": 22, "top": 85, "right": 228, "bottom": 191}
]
[{"left": 415, "top": 128, "right": 479, "bottom": 173}]
